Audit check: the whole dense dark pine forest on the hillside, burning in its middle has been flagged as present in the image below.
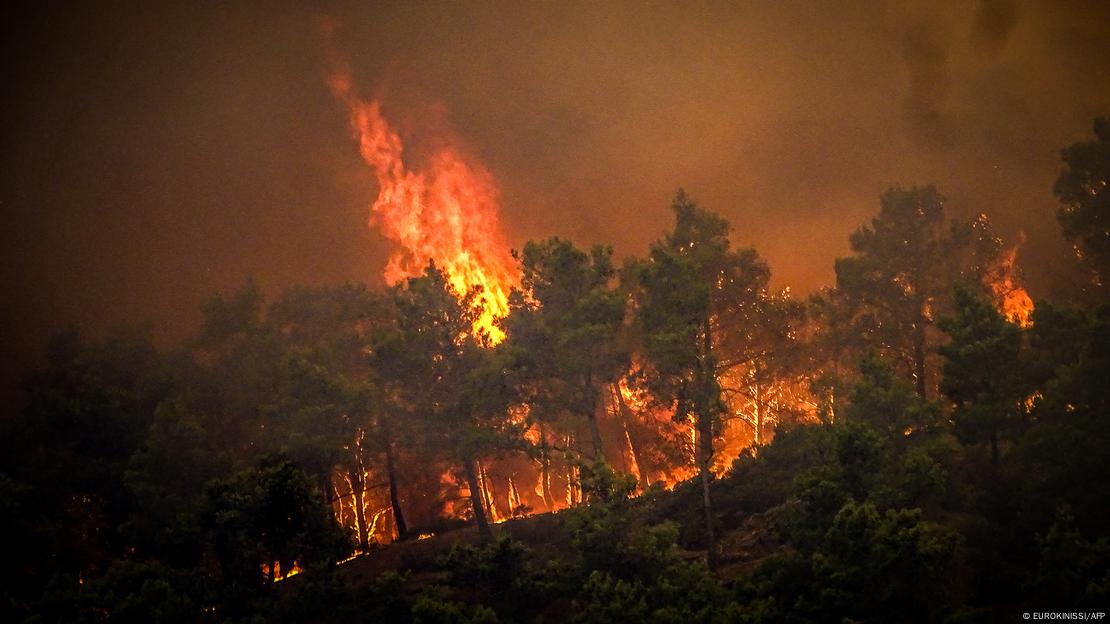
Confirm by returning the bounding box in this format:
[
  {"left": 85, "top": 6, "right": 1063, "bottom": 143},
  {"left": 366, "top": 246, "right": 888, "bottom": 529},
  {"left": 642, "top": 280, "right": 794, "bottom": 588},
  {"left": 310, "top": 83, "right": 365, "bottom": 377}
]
[{"left": 0, "top": 119, "right": 1110, "bottom": 624}]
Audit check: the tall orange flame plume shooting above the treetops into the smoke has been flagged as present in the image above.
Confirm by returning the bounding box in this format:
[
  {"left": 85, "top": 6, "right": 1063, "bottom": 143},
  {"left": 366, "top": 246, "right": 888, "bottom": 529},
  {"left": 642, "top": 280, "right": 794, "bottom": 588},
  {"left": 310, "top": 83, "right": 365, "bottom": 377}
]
[{"left": 329, "top": 72, "right": 518, "bottom": 343}]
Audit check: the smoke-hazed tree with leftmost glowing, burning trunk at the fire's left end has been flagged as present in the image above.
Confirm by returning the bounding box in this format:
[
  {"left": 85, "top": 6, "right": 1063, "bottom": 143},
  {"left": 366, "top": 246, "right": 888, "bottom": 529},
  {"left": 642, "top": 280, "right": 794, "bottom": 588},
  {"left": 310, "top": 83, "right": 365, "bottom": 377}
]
[{"left": 251, "top": 284, "right": 406, "bottom": 552}]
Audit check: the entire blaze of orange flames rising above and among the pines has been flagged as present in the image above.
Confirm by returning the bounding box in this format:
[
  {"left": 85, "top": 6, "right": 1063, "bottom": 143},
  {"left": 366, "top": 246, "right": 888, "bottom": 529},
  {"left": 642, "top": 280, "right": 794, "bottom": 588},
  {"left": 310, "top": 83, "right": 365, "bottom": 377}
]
[{"left": 315, "top": 65, "right": 1032, "bottom": 547}]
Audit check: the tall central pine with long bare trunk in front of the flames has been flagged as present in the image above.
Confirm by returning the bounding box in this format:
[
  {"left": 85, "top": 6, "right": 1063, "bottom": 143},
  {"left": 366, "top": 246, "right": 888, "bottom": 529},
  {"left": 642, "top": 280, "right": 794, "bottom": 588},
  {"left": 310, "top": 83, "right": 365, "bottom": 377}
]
[{"left": 627, "top": 191, "right": 769, "bottom": 567}]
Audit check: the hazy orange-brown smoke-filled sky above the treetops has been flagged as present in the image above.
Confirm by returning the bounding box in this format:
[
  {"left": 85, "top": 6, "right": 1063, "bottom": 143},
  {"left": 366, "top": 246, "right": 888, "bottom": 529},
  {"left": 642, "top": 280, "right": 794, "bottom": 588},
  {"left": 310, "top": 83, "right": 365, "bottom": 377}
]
[{"left": 0, "top": 0, "right": 1110, "bottom": 393}]
